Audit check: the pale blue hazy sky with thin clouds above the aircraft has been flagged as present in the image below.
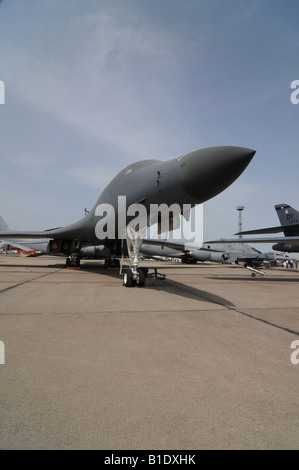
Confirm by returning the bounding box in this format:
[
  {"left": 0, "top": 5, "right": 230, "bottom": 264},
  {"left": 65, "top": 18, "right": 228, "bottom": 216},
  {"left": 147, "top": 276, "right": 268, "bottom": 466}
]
[{"left": 0, "top": 0, "right": 299, "bottom": 253}]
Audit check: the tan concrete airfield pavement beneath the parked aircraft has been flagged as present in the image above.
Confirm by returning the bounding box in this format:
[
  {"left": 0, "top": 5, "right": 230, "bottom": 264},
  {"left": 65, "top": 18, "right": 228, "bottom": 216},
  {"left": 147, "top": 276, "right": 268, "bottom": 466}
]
[{"left": 0, "top": 256, "right": 299, "bottom": 450}]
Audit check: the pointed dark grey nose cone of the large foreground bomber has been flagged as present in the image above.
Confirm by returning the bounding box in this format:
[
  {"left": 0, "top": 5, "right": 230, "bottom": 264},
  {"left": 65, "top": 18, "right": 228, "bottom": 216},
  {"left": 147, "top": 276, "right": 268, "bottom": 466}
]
[{"left": 180, "top": 146, "right": 255, "bottom": 203}]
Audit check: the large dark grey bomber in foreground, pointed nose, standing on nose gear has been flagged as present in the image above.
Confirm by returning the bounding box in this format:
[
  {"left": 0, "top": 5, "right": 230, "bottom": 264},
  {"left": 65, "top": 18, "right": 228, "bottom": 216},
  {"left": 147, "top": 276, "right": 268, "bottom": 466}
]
[{"left": 0, "top": 146, "right": 255, "bottom": 287}]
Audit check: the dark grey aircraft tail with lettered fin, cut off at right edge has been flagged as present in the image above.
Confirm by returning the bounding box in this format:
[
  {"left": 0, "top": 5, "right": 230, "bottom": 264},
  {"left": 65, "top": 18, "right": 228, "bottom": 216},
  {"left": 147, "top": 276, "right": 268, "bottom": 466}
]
[{"left": 207, "top": 203, "right": 299, "bottom": 253}]
